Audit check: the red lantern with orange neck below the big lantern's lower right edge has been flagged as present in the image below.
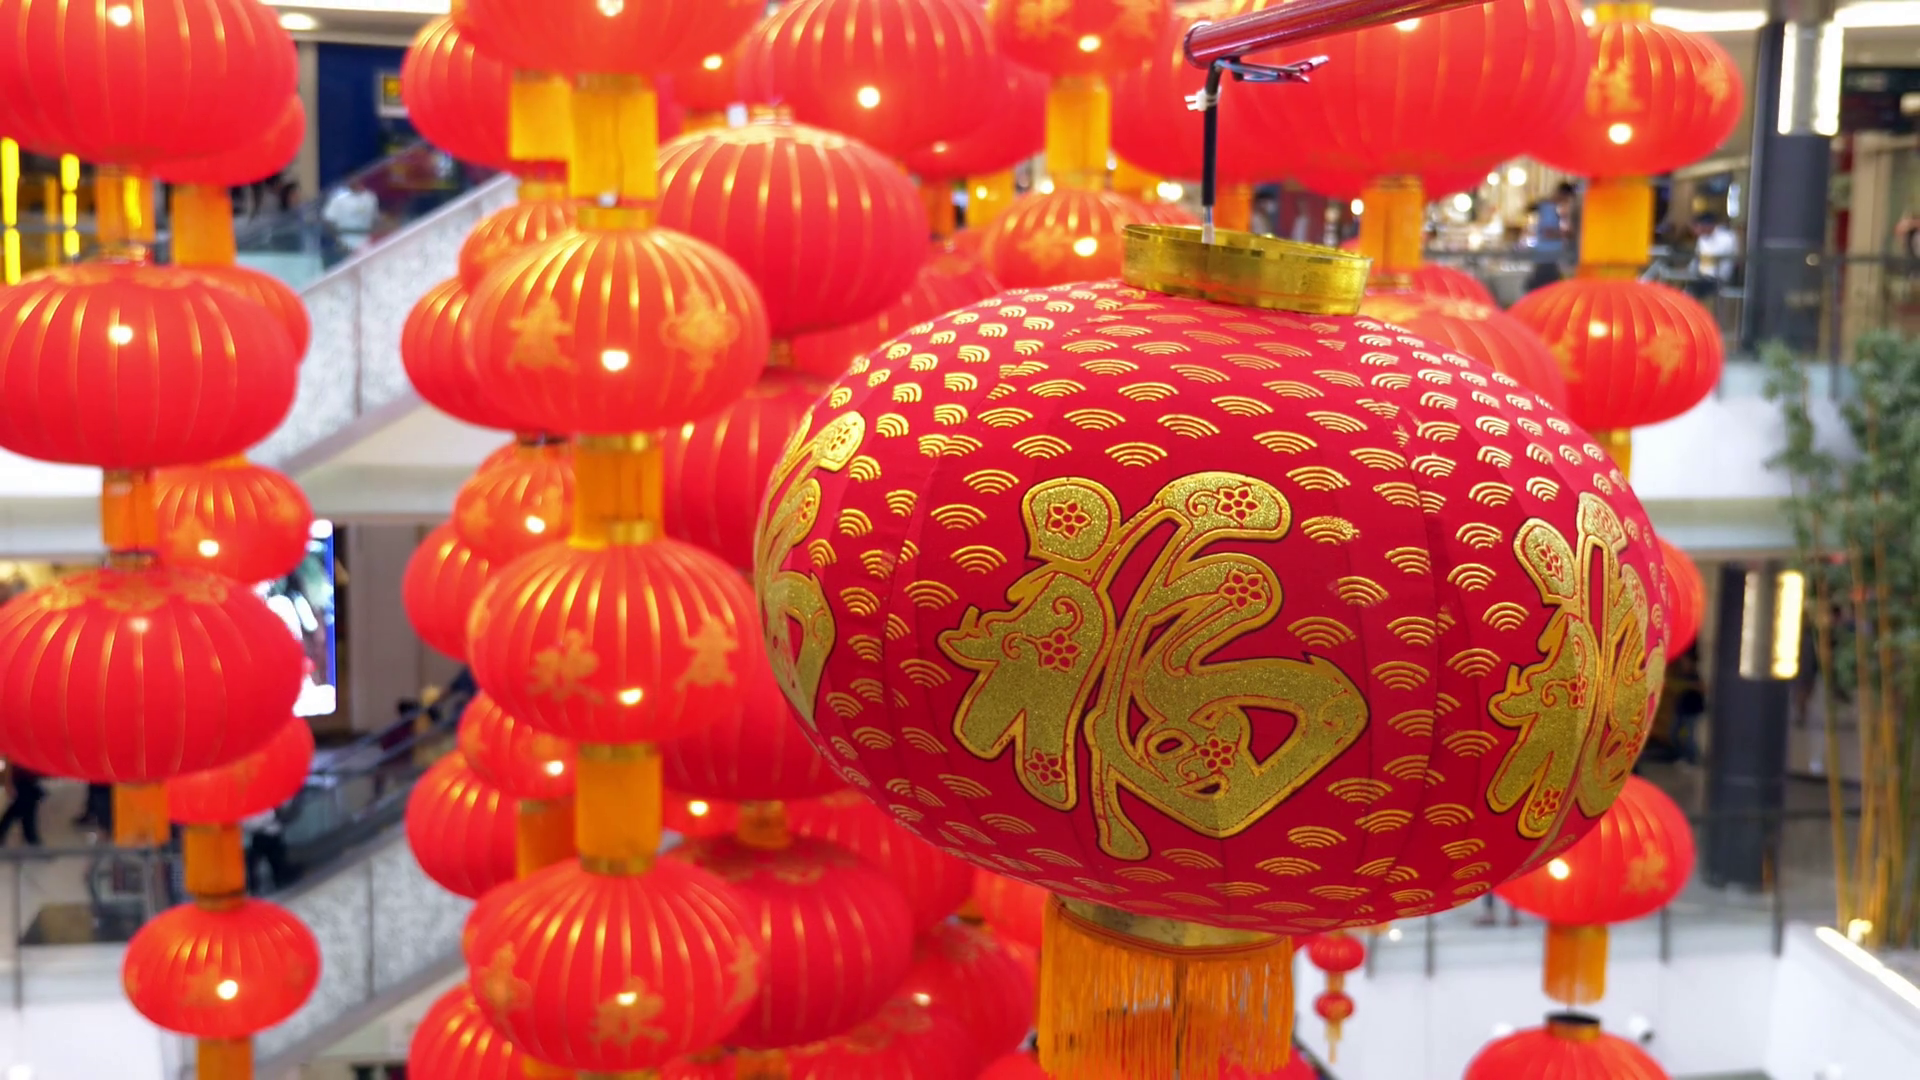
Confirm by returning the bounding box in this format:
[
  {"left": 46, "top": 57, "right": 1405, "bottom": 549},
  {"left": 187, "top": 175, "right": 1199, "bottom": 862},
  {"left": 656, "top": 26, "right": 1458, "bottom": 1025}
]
[{"left": 1498, "top": 772, "right": 1693, "bottom": 1005}]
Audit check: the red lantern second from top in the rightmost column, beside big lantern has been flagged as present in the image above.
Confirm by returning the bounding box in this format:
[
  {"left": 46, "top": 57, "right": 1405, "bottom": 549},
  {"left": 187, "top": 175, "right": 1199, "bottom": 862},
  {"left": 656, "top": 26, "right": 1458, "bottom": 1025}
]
[{"left": 1513, "top": 279, "right": 1726, "bottom": 430}]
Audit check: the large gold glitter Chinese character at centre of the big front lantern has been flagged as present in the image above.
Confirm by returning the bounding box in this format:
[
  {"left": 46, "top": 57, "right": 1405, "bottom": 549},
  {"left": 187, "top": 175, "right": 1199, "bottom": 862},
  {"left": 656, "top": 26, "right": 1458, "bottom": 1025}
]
[{"left": 939, "top": 473, "right": 1367, "bottom": 859}]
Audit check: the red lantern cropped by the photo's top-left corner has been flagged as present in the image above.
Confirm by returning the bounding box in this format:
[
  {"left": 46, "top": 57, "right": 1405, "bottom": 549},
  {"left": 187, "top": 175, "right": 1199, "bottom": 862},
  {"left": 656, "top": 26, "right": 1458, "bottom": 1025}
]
[{"left": 0, "top": 0, "right": 298, "bottom": 165}]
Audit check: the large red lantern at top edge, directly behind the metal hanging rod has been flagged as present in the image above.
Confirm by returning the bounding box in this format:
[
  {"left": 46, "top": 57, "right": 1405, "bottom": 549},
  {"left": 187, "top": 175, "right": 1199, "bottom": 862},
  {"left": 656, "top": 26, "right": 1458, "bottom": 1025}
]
[{"left": 1235, "top": 0, "right": 1594, "bottom": 194}]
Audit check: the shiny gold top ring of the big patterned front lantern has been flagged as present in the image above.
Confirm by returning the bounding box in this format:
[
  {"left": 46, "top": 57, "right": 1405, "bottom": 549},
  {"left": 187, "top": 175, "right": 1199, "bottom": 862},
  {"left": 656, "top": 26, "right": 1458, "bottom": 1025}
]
[{"left": 1121, "top": 225, "right": 1373, "bottom": 315}]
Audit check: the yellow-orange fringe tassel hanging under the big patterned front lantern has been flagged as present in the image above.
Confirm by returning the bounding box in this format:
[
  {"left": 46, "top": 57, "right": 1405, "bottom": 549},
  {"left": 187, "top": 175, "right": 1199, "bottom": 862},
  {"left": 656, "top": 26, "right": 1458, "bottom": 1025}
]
[{"left": 1041, "top": 897, "right": 1294, "bottom": 1080}]
